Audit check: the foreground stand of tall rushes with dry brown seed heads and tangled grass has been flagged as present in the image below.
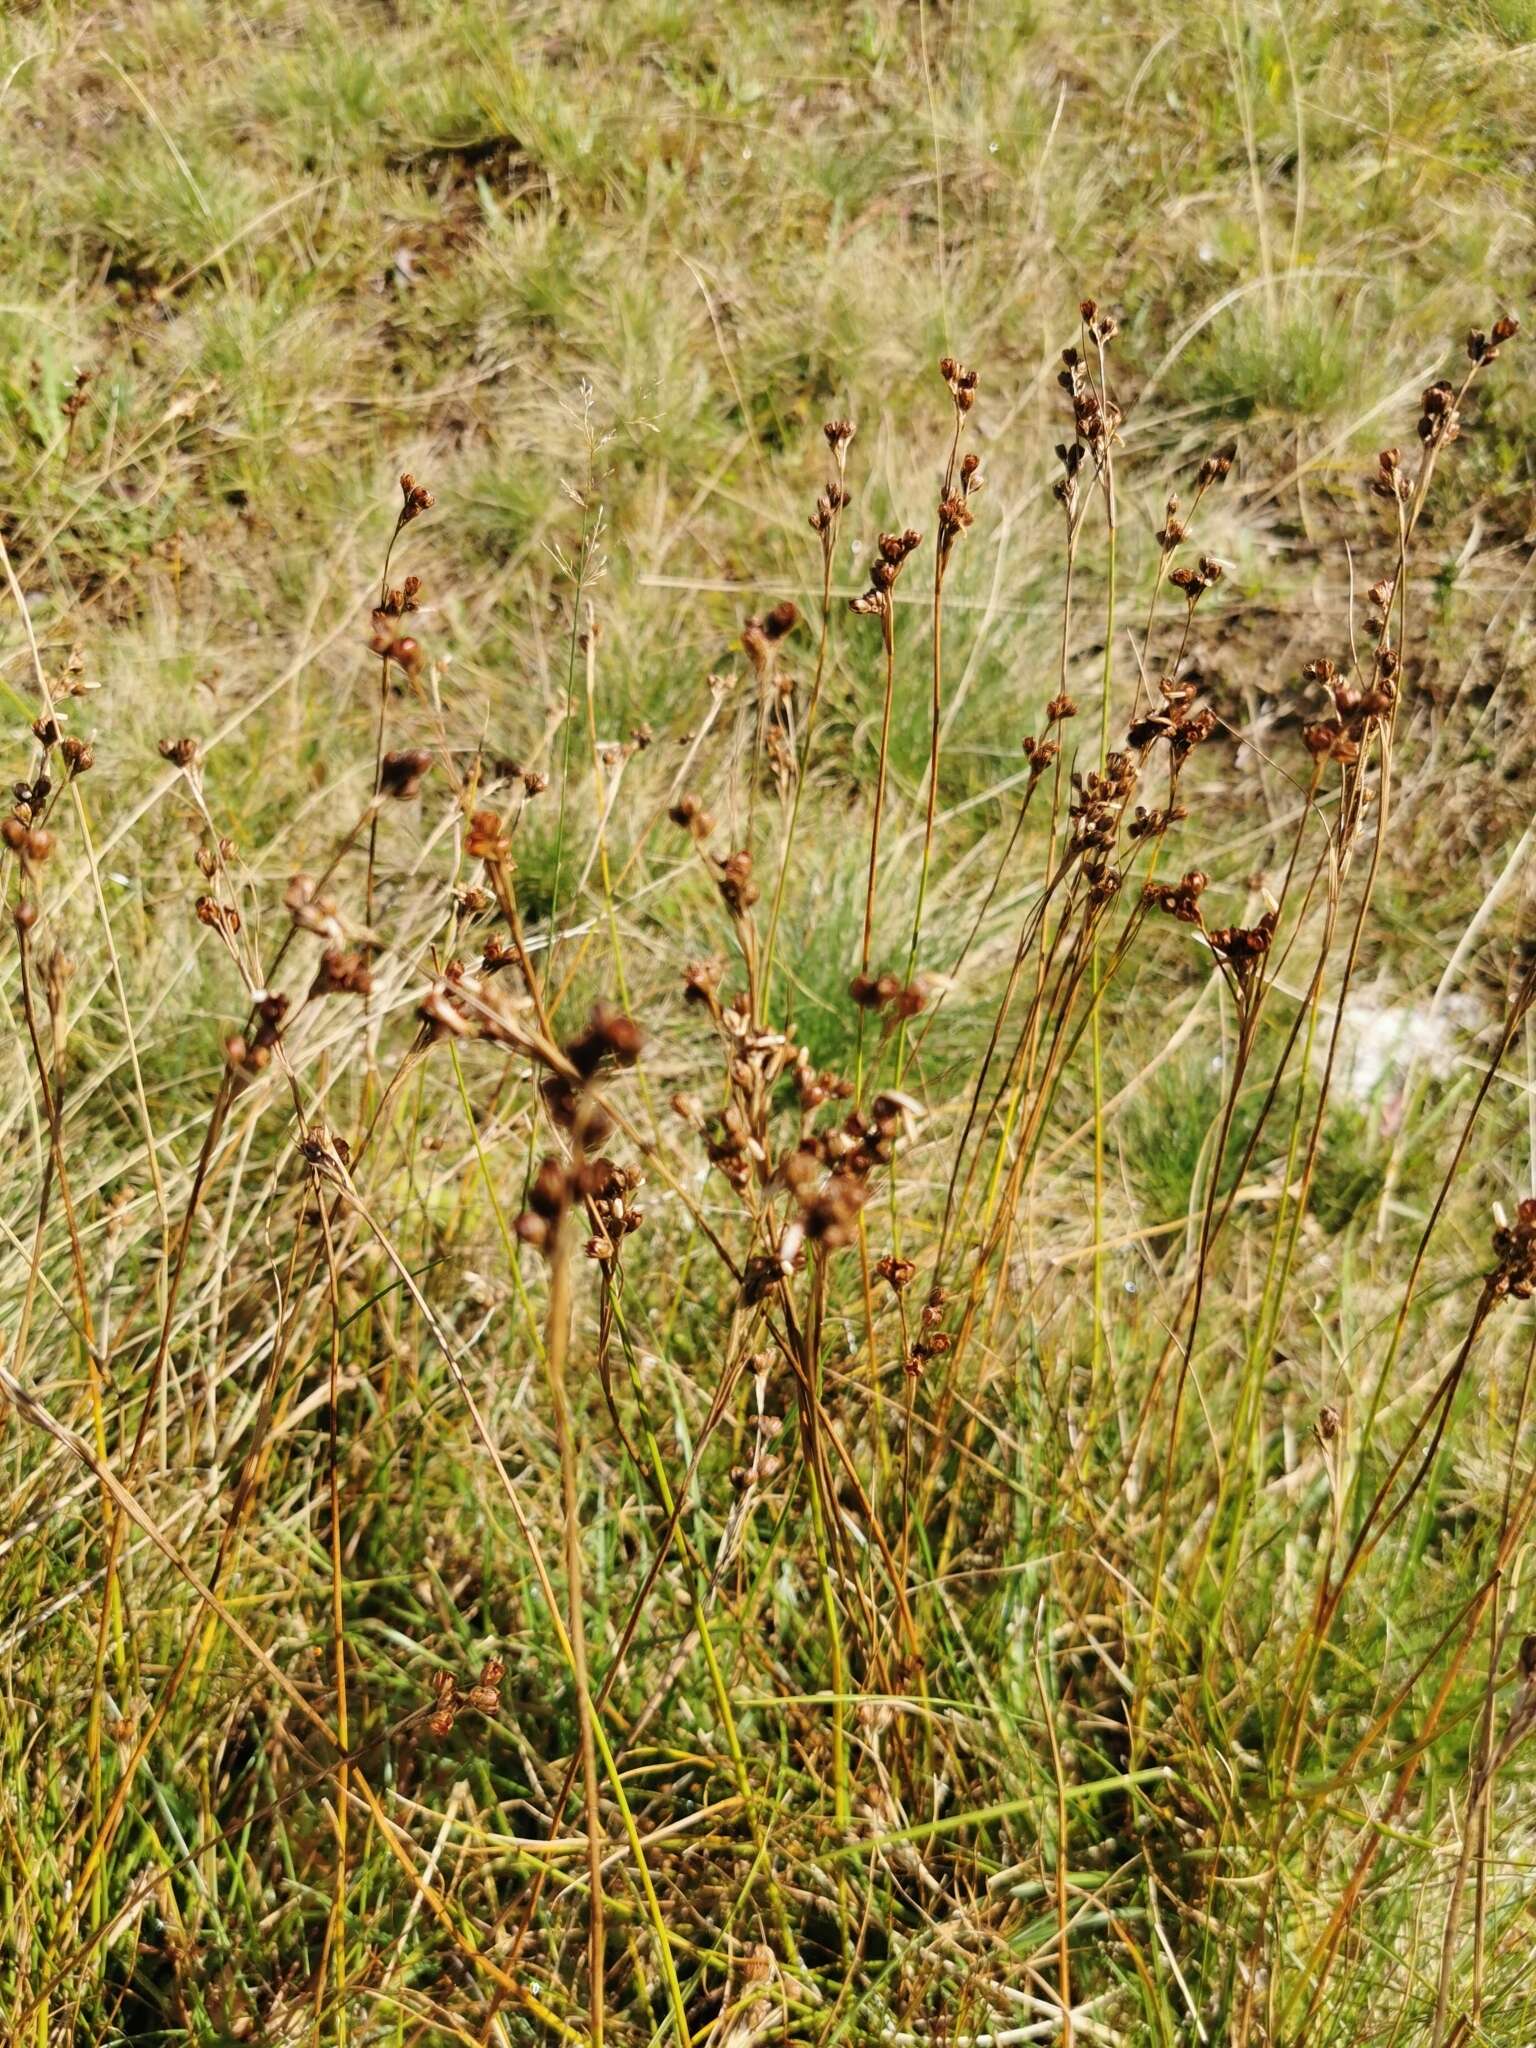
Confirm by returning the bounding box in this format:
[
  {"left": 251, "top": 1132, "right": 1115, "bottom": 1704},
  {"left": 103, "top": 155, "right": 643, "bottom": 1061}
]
[{"left": 0, "top": 284, "right": 1536, "bottom": 2048}]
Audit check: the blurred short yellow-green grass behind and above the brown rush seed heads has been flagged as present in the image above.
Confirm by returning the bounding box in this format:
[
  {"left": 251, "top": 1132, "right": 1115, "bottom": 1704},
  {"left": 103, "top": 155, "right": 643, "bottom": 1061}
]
[{"left": 0, "top": 0, "right": 1536, "bottom": 1105}]
